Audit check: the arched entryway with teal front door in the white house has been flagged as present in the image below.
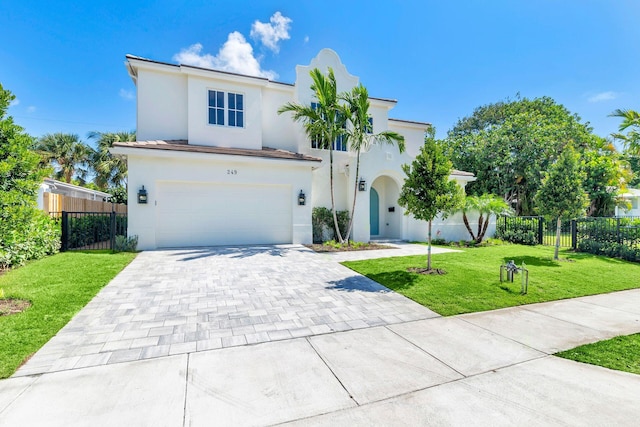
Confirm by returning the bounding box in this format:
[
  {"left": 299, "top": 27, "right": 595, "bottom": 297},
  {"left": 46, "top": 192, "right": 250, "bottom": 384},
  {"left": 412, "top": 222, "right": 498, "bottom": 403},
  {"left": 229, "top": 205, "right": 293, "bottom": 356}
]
[{"left": 369, "top": 175, "right": 402, "bottom": 239}]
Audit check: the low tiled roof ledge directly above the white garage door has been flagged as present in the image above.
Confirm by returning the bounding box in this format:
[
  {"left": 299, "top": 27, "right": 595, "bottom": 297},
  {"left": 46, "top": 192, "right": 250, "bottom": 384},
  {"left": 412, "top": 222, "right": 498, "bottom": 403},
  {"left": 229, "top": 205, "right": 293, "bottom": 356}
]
[{"left": 113, "top": 139, "right": 322, "bottom": 162}]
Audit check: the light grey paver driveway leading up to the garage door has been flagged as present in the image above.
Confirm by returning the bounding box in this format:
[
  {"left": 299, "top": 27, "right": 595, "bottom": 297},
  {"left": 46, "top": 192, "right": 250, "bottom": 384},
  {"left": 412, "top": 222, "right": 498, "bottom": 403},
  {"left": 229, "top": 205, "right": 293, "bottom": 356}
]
[{"left": 16, "top": 245, "right": 437, "bottom": 376}]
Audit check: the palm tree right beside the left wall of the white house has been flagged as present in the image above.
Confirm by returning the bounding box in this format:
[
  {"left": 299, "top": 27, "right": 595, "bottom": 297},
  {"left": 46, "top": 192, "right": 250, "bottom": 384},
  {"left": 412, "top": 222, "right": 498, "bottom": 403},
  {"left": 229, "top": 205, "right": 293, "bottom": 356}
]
[{"left": 88, "top": 131, "right": 136, "bottom": 190}]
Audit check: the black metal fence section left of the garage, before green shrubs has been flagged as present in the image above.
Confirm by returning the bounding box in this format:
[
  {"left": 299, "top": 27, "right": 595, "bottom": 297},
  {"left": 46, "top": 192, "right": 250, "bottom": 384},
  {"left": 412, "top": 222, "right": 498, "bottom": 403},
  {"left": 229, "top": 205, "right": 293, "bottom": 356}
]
[{"left": 57, "top": 211, "right": 127, "bottom": 252}]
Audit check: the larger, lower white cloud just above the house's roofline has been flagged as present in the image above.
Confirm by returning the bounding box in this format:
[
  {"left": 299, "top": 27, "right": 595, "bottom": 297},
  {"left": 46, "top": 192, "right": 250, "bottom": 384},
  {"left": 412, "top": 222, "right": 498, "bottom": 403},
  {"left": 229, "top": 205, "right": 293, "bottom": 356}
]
[{"left": 173, "top": 31, "right": 278, "bottom": 80}]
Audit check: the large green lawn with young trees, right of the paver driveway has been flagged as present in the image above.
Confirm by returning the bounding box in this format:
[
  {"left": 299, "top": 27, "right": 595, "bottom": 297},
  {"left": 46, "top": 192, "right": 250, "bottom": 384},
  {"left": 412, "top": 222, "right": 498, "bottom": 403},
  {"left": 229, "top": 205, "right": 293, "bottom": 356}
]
[{"left": 343, "top": 245, "right": 640, "bottom": 316}]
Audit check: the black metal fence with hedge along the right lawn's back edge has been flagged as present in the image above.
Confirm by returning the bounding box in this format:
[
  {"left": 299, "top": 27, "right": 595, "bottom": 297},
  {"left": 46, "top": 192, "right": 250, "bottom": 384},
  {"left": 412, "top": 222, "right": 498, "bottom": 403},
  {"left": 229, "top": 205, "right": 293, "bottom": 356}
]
[{"left": 496, "top": 216, "right": 640, "bottom": 261}]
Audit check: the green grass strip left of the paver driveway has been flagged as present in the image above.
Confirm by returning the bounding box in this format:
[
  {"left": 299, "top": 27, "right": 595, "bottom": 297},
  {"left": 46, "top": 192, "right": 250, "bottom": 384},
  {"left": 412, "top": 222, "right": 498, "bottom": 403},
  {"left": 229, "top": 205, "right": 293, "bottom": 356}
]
[{"left": 0, "top": 251, "right": 135, "bottom": 378}]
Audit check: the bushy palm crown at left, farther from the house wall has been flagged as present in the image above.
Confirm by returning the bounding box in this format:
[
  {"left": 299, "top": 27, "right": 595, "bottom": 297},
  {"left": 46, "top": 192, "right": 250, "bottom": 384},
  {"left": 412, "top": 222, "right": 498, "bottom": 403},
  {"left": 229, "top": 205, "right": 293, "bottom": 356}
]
[{"left": 34, "top": 132, "right": 91, "bottom": 183}]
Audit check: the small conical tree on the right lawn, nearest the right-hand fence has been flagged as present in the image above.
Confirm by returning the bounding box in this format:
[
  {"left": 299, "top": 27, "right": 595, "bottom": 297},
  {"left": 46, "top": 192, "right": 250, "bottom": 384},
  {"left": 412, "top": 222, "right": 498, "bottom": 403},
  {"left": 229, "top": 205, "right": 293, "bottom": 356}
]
[{"left": 535, "top": 145, "right": 589, "bottom": 260}]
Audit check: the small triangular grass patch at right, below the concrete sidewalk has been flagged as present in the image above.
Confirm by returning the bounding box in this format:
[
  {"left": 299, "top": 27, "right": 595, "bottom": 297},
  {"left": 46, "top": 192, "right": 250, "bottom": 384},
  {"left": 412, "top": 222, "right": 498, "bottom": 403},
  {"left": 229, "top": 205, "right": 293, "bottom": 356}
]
[{"left": 556, "top": 334, "right": 640, "bottom": 374}]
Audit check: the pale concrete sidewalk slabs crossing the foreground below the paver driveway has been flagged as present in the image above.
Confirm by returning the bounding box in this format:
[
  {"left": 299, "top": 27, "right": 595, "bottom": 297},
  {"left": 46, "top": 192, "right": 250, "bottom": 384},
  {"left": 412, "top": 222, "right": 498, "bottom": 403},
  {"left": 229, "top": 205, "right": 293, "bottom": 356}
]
[{"left": 0, "top": 244, "right": 640, "bottom": 426}]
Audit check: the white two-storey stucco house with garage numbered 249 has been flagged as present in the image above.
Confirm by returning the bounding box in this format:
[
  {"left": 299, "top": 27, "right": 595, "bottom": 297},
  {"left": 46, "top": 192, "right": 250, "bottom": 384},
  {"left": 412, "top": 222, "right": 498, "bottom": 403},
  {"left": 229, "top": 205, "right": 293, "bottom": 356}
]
[{"left": 112, "top": 49, "right": 475, "bottom": 249}]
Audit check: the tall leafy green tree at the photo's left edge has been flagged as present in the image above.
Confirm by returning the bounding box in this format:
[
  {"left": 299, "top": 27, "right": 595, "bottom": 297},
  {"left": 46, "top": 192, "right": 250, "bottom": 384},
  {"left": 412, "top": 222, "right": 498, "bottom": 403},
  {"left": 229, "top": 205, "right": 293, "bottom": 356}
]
[{"left": 0, "top": 84, "right": 60, "bottom": 269}]
